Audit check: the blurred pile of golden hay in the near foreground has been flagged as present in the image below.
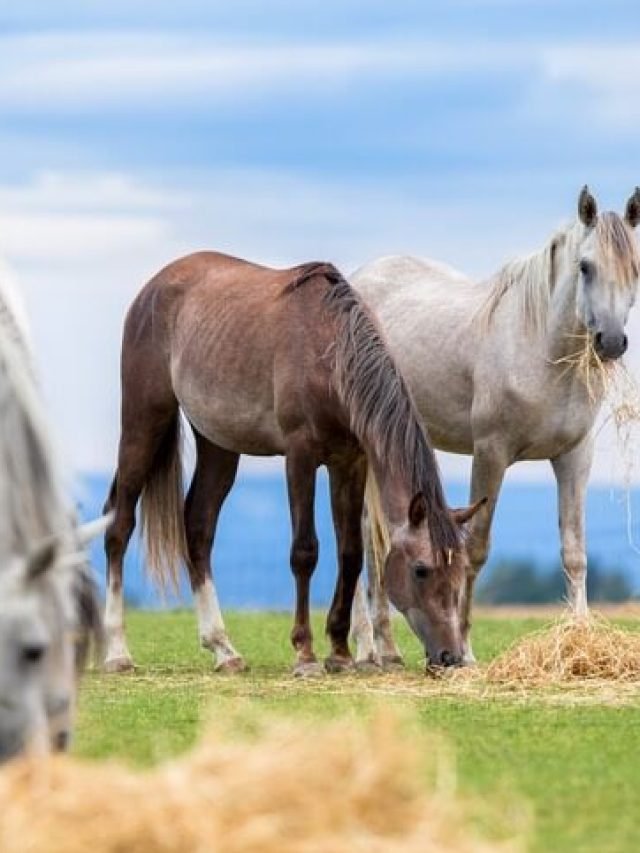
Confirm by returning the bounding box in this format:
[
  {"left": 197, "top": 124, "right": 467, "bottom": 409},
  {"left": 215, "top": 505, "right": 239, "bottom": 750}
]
[{"left": 0, "top": 718, "right": 521, "bottom": 853}]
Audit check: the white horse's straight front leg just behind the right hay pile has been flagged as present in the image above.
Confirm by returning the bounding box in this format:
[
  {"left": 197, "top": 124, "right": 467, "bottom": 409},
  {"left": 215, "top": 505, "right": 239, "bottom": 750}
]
[{"left": 551, "top": 435, "right": 593, "bottom": 616}]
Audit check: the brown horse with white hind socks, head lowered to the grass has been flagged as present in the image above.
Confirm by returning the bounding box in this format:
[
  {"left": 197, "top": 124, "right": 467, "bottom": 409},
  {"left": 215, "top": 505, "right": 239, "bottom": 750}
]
[{"left": 101, "top": 252, "right": 480, "bottom": 675}]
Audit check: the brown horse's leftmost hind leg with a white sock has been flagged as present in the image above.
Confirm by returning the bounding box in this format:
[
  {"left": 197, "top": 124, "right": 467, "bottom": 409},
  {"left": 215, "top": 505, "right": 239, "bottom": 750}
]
[{"left": 104, "top": 399, "right": 178, "bottom": 672}]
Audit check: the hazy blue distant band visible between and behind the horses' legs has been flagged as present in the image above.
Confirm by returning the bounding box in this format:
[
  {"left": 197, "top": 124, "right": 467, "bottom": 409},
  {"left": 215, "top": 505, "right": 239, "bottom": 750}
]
[{"left": 80, "top": 472, "right": 640, "bottom": 610}]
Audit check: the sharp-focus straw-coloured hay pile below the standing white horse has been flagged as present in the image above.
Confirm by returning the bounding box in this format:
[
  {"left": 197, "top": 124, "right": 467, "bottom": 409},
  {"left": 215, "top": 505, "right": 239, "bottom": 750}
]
[{"left": 486, "top": 615, "right": 640, "bottom": 685}]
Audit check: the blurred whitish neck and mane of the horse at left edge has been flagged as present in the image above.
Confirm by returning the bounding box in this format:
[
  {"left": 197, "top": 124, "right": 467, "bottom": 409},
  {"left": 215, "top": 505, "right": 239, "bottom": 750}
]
[{"left": 0, "top": 294, "right": 68, "bottom": 551}]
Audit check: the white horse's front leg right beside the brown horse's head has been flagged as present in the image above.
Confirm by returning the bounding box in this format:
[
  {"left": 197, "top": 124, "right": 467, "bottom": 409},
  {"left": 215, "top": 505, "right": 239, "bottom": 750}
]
[{"left": 460, "top": 441, "right": 508, "bottom": 665}]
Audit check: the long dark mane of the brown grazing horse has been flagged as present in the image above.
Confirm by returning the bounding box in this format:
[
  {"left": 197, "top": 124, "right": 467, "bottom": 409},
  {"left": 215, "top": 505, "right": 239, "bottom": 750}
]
[{"left": 284, "top": 263, "right": 460, "bottom": 555}]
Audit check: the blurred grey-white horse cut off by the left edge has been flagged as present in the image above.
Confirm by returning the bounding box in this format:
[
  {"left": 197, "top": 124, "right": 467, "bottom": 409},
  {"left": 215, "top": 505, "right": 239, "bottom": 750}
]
[{"left": 0, "top": 262, "right": 104, "bottom": 761}]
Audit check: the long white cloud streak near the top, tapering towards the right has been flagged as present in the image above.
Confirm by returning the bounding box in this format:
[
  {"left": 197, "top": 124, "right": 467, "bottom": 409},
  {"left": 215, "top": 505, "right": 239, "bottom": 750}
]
[{"left": 0, "top": 32, "right": 526, "bottom": 114}]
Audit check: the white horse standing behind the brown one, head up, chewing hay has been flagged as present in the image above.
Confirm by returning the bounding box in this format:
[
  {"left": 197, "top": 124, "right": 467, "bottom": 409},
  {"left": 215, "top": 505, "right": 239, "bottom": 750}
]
[{"left": 351, "top": 187, "right": 640, "bottom": 665}]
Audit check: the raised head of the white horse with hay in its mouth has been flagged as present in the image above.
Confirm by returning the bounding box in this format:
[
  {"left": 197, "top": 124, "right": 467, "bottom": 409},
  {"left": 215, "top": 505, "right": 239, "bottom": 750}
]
[{"left": 568, "top": 187, "right": 640, "bottom": 361}]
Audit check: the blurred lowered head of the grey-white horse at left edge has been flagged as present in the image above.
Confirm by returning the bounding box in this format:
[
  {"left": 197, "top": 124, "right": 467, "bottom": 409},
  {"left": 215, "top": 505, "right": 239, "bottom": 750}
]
[{"left": 0, "top": 538, "right": 100, "bottom": 761}]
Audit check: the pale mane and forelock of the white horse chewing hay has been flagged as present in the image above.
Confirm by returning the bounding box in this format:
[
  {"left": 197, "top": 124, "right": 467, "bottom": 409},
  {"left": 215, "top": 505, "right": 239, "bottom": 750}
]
[{"left": 474, "top": 211, "right": 640, "bottom": 334}]
